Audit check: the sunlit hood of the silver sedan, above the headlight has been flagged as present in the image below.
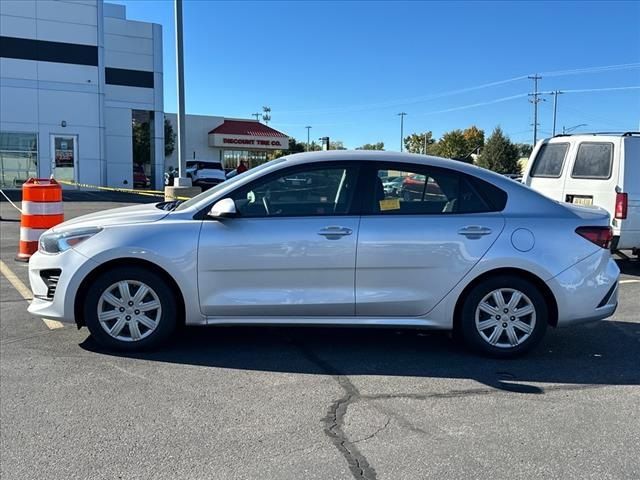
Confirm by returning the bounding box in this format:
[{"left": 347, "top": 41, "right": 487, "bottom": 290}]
[{"left": 53, "top": 203, "right": 169, "bottom": 231}]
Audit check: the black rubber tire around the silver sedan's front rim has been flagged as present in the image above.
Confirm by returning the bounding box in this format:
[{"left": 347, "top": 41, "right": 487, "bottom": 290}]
[{"left": 83, "top": 266, "right": 177, "bottom": 352}]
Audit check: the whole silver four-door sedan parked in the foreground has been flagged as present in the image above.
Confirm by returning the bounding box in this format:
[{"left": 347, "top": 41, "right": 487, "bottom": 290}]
[{"left": 29, "top": 151, "right": 620, "bottom": 357}]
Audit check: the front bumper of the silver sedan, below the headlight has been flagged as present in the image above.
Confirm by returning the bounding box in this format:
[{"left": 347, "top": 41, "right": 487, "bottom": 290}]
[{"left": 28, "top": 248, "right": 97, "bottom": 323}]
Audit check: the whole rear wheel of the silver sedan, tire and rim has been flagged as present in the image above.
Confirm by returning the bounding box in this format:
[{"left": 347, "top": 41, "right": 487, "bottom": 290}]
[{"left": 460, "top": 276, "right": 548, "bottom": 357}]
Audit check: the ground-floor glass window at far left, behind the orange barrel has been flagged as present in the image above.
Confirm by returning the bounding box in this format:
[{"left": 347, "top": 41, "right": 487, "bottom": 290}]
[{"left": 0, "top": 132, "right": 38, "bottom": 187}]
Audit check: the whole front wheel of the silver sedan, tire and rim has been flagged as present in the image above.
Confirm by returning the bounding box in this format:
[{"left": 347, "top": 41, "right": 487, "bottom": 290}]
[{"left": 84, "top": 267, "right": 177, "bottom": 351}]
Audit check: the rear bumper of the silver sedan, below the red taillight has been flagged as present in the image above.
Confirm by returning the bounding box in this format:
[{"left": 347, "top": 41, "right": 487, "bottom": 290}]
[{"left": 547, "top": 249, "right": 620, "bottom": 327}]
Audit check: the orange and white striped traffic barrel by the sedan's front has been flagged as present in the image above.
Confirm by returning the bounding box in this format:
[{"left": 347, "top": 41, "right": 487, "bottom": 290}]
[{"left": 16, "top": 178, "right": 64, "bottom": 262}]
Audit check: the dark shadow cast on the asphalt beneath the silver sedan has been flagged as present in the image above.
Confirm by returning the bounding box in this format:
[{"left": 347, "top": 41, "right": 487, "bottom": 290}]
[{"left": 81, "top": 321, "right": 640, "bottom": 394}]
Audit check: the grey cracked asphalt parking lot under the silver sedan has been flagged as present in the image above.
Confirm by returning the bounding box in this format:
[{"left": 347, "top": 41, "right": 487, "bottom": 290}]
[{"left": 0, "top": 194, "right": 640, "bottom": 480}]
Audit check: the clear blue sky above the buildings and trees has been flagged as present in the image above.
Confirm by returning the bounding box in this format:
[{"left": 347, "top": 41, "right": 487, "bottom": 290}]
[{"left": 113, "top": 0, "right": 640, "bottom": 150}]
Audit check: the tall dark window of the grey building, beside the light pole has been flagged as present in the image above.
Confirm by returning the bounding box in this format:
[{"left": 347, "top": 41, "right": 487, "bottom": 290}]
[{"left": 131, "top": 110, "right": 155, "bottom": 188}]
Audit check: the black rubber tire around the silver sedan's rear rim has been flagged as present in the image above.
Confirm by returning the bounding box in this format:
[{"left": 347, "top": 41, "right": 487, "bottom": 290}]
[{"left": 456, "top": 275, "right": 549, "bottom": 358}]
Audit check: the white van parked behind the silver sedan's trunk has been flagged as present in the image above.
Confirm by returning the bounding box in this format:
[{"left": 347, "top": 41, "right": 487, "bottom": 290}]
[{"left": 522, "top": 132, "right": 640, "bottom": 255}]
